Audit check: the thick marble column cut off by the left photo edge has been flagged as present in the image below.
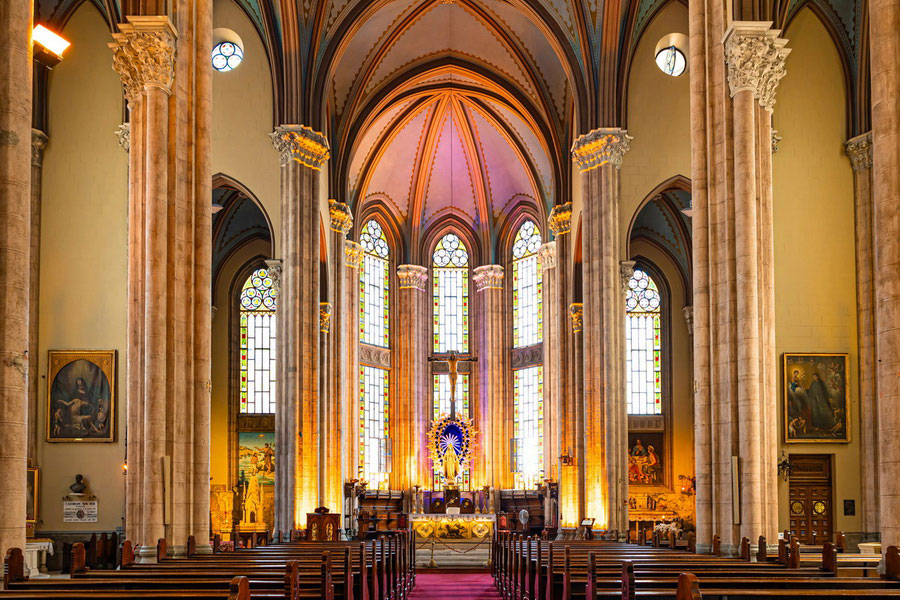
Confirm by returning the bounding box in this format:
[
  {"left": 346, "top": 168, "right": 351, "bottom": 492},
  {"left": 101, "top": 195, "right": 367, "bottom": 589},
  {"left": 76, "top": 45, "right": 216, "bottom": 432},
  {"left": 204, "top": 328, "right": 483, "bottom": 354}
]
[{"left": 0, "top": 0, "right": 36, "bottom": 556}]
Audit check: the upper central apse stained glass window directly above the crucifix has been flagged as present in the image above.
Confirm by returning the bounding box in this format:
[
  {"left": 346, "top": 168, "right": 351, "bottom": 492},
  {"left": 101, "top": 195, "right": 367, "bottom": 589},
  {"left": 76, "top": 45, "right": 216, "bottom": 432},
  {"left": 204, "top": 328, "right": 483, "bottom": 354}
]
[{"left": 432, "top": 233, "right": 469, "bottom": 352}]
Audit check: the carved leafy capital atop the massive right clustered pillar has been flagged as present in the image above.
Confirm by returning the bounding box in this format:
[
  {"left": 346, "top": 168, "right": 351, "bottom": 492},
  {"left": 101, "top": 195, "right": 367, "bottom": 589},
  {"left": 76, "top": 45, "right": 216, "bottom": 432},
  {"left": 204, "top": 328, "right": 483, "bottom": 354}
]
[{"left": 722, "top": 21, "right": 791, "bottom": 110}]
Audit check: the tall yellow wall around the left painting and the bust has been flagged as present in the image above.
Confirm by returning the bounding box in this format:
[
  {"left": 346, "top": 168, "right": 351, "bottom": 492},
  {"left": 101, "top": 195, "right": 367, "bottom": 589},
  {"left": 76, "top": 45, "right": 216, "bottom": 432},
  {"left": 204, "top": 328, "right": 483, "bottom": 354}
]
[{"left": 36, "top": 3, "right": 128, "bottom": 532}]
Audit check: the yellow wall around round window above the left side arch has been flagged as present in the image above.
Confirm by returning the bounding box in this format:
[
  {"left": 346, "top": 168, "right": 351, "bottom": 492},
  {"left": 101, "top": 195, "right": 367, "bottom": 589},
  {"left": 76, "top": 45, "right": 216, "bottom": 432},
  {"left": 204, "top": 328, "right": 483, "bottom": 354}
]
[{"left": 212, "top": 0, "right": 281, "bottom": 253}]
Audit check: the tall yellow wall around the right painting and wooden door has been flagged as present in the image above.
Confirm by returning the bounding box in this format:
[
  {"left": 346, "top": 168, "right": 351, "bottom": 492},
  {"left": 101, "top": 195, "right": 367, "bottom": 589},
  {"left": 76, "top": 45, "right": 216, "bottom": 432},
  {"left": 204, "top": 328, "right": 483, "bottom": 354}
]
[{"left": 774, "top": 9, "right": 861, "bottom": 532}]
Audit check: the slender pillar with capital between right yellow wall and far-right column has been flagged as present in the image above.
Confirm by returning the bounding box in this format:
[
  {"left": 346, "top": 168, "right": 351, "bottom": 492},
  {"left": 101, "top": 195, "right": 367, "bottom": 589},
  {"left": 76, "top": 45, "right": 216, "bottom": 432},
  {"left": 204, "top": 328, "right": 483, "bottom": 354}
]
[{"left": 846, "top": 132, "right": 881, "bottom": 539}]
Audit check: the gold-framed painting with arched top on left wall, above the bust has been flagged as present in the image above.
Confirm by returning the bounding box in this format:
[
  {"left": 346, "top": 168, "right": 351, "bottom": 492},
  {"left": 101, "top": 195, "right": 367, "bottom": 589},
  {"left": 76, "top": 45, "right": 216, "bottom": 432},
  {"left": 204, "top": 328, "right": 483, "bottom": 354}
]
[{"left": 47, "top": 350, "right": 116, "bottom": 442}]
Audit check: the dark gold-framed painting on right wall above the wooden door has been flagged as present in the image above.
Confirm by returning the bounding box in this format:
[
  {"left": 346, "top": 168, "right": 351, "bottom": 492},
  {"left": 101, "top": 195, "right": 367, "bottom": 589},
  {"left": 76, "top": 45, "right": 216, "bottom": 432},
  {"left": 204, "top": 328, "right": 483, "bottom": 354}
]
[{"left": 782, "top": 353, "right": 850, "bottom": 443}]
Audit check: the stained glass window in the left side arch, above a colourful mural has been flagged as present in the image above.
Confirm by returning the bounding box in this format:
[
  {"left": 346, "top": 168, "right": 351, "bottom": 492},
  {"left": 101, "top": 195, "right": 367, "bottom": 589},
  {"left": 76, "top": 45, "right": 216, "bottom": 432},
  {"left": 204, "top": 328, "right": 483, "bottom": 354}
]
[{"left": 240, "top": 269, "right": 276, "bottom": 414}]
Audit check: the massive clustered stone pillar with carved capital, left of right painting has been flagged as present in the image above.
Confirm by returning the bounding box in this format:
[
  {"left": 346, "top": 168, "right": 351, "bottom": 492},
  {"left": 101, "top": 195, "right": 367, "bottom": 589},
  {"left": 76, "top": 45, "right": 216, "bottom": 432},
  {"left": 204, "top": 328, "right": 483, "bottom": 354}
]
[{"left": 690, "top": 17, "right": 789, "bottom": 552}]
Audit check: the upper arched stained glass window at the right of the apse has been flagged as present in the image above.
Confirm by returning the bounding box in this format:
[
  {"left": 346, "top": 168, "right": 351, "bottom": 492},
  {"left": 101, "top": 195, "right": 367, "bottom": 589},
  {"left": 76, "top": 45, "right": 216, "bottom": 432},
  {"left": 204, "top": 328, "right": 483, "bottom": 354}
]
[{"left": 512, "top": 220, "right": 544, "bottom": 348}]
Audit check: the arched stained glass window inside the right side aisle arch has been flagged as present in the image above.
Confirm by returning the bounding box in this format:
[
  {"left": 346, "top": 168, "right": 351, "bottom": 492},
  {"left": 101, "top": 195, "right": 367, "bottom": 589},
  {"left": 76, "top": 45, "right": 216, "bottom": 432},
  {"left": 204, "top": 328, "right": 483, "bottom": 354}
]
[{"left": 625, "top": 269, "right": 662, "bottom": 415}]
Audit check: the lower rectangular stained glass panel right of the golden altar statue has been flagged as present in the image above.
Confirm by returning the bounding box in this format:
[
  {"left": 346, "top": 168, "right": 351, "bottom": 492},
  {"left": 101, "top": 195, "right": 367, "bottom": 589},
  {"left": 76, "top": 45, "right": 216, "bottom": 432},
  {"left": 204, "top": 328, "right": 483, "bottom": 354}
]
[{"left": 513, "top": 366, "right": 544, "bottom": 490}]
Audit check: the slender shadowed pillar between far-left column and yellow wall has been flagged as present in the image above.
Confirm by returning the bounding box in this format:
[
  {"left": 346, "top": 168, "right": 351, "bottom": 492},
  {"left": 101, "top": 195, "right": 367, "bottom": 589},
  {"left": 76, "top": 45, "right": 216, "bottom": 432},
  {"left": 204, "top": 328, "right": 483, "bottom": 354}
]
[{"left": 28, "top": 129, "right": 47, "bottom": 464}]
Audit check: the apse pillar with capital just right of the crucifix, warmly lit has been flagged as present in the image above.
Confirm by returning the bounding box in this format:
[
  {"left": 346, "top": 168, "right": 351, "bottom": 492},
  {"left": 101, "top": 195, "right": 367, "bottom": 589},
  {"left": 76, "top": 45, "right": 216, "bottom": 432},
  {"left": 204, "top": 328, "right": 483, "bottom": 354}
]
[{"left": 472, "top": 265, "right": 506, "bottom": 489}]
